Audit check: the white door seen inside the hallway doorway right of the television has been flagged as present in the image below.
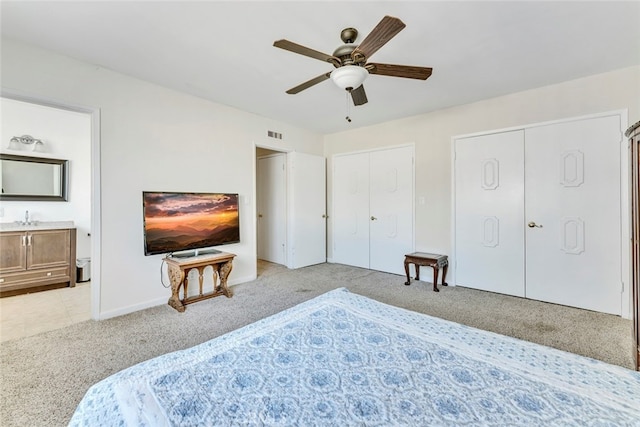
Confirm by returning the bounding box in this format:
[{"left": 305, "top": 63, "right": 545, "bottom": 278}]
[{"left": 256, "top": 154, "right": 287, "bottom": 264}]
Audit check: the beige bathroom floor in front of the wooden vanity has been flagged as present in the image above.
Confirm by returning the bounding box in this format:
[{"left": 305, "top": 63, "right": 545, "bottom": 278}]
[{"left": 0, "top": 282, "right": 91, "bottom": 342}]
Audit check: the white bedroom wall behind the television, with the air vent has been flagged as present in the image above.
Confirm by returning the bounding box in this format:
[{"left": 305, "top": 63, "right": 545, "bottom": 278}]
[{"left": 1, "top": 39, "right": 322, "bottom": 318}]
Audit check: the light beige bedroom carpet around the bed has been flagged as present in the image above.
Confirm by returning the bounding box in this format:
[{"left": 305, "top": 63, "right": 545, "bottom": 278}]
[{"left": 0, "top": 263, "right": 633, "bottom": 426}]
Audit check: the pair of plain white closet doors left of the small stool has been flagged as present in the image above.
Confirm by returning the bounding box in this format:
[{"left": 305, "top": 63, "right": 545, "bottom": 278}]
[{"left": 333, "top": 146, "right": 414, "bottom": 274}]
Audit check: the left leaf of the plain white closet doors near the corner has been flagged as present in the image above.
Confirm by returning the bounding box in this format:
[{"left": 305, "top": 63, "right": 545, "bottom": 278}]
[{"left": 332, "top": 153, "right": 371, "bottom": 268}]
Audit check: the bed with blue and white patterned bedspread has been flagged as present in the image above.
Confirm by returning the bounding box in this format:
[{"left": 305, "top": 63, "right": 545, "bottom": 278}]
[{"left": 70, "top": 288, "right": 640, "bottom": 427}]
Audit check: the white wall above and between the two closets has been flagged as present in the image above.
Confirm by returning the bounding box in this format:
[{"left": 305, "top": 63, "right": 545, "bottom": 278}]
[{"left": 324, "top": 66, "right": 640, "bottom": 262}]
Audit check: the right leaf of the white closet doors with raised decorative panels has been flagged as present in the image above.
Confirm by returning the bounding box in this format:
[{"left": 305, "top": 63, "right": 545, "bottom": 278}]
[{"left": 525, "top": 116, "right": 622, "bottom": 315}]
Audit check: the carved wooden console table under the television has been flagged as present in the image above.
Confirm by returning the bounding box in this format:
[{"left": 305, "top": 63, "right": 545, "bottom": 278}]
[{"left": 164, "top": 252, "right": 235, "bottom": 312}]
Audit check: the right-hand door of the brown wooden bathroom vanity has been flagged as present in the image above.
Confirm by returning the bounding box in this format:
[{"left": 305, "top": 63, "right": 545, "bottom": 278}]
[{"left": 27, "top": 229, "right": 71, "bottom": 269}]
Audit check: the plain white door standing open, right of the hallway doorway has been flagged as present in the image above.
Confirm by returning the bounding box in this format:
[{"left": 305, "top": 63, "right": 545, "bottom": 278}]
[{"left": 288, "top": 152, "right": 327, "bottom": 268}]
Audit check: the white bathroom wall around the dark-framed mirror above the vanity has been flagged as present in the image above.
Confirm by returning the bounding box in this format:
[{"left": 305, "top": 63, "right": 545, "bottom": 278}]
[{"left": 0, "top": 98, "right": 91, "bottom": 258}]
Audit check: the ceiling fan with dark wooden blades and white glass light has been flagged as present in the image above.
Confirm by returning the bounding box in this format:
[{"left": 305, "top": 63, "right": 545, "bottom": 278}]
[{"left": 273, "top": 16, "right": 432, "bottom": 105}]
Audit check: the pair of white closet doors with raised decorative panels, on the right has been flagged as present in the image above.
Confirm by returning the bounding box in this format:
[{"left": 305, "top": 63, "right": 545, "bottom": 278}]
[{"left": 455, "top": 115, "right": 622, "bottom": 315}]
